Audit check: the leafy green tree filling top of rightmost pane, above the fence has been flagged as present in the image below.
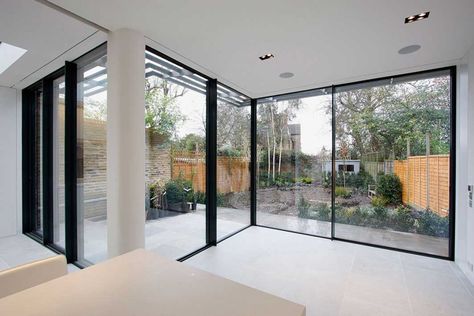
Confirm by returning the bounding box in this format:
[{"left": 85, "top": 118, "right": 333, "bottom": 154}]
[{"left": 326, "top": 77, "right": 450, "bottom": 158}]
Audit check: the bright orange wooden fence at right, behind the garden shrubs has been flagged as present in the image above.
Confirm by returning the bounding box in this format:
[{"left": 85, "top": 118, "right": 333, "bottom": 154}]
[{"left": 393, "top": 155, "right": 449, "bottom": 216}]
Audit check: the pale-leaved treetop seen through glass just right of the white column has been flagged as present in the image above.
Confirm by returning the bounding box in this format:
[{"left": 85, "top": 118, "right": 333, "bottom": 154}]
[{"left": 145, "top": 78, "right": 186, "bottom": 141}]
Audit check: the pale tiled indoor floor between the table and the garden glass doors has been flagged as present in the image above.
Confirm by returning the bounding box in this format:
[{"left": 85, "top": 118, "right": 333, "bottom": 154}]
[{"left": 185, "top": 227, "right": 474, "bottom": 316}]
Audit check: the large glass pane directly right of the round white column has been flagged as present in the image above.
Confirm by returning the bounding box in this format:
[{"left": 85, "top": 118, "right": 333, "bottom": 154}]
[{"left": 145, "top": 51, "right": 207, "bottom": 259}]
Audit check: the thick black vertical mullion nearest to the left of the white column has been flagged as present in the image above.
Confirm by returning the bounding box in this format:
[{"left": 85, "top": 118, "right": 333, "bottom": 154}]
[{"left": 64, "top": 62, "right": 78, "bottom": 263}]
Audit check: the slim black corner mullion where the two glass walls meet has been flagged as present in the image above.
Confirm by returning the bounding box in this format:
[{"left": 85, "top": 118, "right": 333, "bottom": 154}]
[{"left": 250, "top": 99, "right": 258, "bottom": 226}]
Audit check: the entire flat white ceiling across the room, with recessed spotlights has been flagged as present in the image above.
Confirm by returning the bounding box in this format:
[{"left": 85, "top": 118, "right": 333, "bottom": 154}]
[{"left": 0, "top": 0, "right": 474, "bottom": 97}]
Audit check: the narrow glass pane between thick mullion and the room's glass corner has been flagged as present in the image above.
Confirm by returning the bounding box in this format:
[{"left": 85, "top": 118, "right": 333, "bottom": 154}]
[{"left": 217, "top": 85, "right": 250, "bottom": 239}]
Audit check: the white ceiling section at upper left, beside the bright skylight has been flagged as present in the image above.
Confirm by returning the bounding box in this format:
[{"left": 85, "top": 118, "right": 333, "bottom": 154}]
[{"left": 0, "top": 0, "right": 106, "bottom": 89}]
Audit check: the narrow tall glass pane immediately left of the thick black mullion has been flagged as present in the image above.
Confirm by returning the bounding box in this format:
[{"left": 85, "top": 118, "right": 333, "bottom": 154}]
[{"left": 53, "top": 76, "right": 66, "bottom": 249}]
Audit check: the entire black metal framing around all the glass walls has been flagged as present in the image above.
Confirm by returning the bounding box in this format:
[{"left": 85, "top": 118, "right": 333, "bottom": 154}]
[{"left": 22, "top": 43, "right": 457, "bottom": 267}]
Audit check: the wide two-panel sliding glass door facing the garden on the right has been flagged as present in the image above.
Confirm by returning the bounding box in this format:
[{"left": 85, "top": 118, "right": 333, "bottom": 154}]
[{"left": 256, "top": 68, "right": 455, "bottom": 258}]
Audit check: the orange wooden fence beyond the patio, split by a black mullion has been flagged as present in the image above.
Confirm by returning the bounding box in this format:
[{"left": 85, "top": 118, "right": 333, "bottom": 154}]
[{"left": 171, "top": 152, "right": 250, "bottom": 193}]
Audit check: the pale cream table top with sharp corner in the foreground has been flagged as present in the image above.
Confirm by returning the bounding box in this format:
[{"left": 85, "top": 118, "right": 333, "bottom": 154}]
[{"left": 0, "top": 249, "right": 306, "bottom": 316}]
